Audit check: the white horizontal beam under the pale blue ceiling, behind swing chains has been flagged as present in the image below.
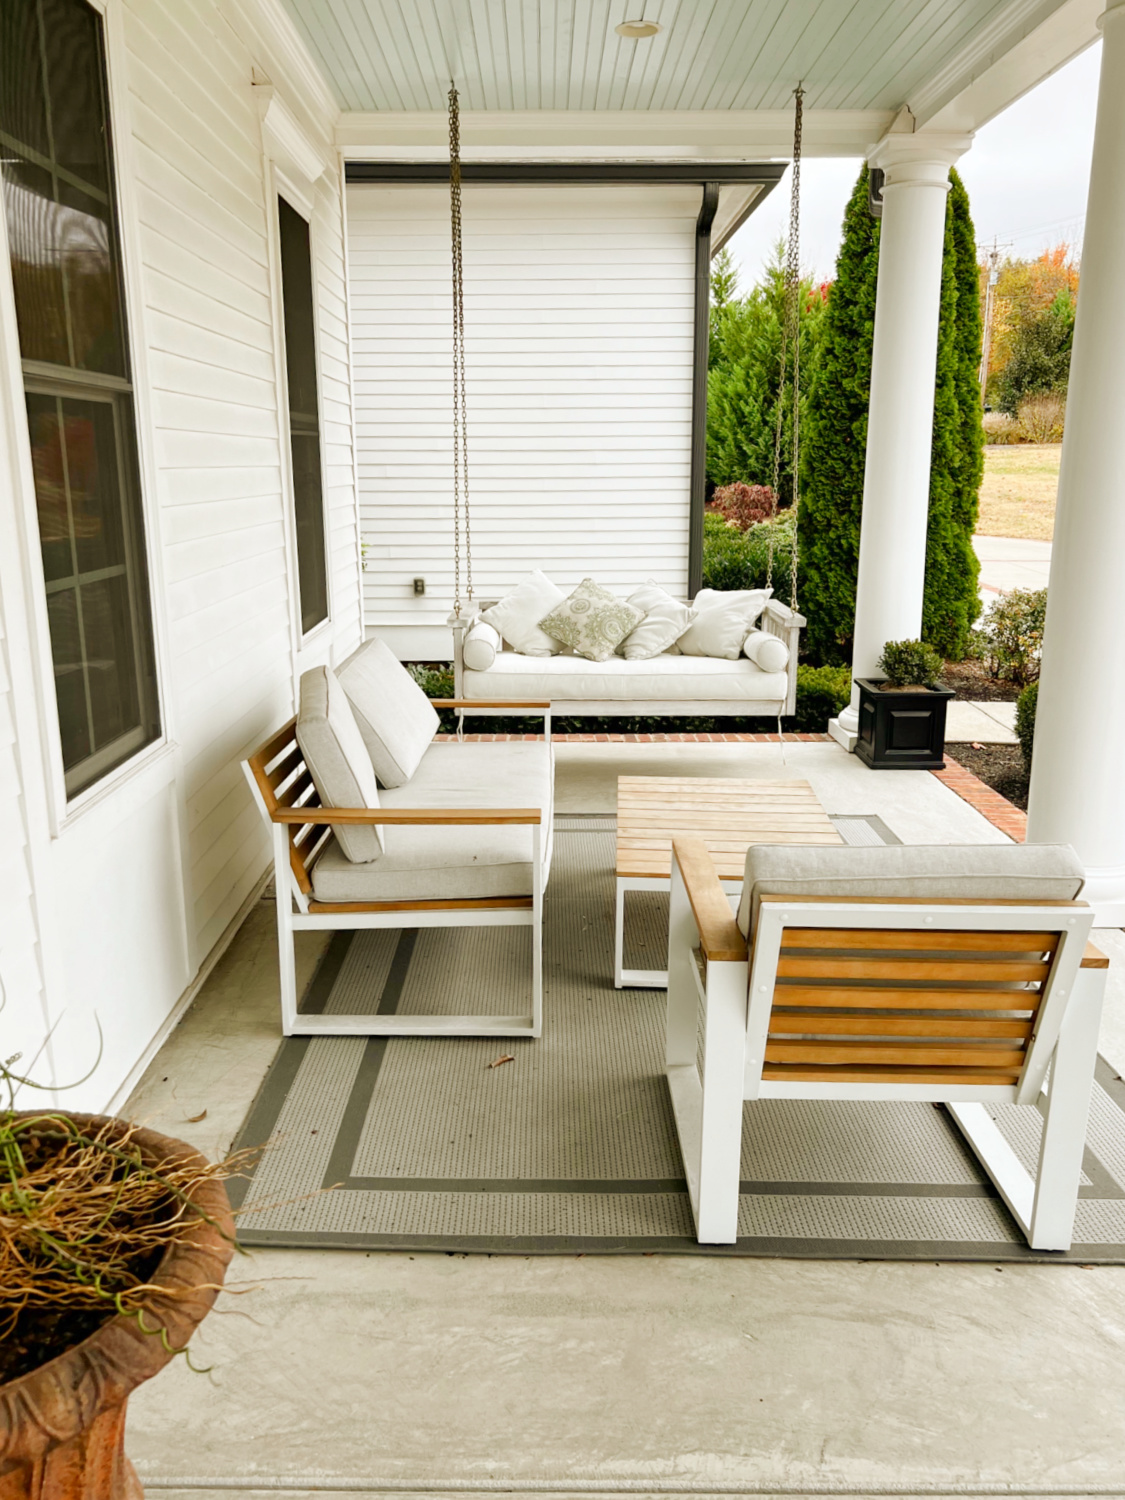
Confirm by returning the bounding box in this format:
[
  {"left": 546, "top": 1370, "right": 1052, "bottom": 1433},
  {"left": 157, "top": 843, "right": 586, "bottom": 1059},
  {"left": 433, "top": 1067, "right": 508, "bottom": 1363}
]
[{"left": 336, "top": 110, "right": 894, "bottom": 162}]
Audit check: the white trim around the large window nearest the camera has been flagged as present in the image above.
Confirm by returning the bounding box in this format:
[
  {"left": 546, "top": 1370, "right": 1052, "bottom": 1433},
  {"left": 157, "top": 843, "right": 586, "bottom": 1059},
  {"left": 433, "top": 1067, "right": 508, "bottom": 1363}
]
[{"left": 0, "top": 0, "right": 182, "bottom": 839}]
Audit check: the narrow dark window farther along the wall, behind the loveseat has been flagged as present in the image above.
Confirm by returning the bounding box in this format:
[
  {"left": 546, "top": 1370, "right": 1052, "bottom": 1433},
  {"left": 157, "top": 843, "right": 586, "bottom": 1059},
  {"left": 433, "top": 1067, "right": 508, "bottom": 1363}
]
[{"left": 278, "top": 198, "right": 329, "bottom": 635}]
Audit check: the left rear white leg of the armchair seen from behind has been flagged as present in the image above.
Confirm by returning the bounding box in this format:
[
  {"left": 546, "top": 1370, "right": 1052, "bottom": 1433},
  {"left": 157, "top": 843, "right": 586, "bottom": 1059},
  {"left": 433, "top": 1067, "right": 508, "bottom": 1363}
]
[{"left": 696, "top": 962, "right": 747, "bottom": 1245}]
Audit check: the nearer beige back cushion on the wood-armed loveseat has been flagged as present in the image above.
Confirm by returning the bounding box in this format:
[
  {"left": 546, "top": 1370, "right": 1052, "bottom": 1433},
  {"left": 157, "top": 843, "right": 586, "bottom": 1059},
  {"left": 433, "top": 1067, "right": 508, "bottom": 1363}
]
[{"left": 297, "top": 666, "right": 384, "bottom": 864}]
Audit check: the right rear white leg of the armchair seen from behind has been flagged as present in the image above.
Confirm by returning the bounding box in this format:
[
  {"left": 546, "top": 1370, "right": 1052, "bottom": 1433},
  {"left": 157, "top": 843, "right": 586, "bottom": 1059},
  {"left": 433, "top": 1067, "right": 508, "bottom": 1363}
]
[{"left": 1028, "top": 969, "right": 1106, "bottom": 1250}]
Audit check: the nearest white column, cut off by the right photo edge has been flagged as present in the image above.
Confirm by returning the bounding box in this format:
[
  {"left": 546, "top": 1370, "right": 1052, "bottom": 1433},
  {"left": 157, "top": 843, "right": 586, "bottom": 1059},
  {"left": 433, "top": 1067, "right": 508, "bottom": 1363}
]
[{"left": 1028, "top": 5, "right": 1125, "bottom": 927}]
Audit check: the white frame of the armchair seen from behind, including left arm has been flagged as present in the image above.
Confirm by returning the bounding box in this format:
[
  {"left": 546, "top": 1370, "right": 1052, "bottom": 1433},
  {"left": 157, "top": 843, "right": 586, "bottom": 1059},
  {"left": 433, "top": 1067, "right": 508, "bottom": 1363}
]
[{"left": 666, "top": 840, "right": 1109, "bottom": 1251}]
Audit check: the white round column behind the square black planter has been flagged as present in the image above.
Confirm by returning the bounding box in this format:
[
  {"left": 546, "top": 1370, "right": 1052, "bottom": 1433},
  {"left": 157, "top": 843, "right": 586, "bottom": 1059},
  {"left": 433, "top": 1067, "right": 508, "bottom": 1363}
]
[{"left": 830, "top": 134, "right": 971, "bottom": 749}]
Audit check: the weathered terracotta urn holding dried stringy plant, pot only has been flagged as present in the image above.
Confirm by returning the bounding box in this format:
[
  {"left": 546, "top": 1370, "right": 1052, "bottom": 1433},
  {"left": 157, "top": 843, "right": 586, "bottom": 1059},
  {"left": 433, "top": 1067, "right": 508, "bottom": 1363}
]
[{"left": 0, "top": 1115, "right": 234, "bottom": 1500}]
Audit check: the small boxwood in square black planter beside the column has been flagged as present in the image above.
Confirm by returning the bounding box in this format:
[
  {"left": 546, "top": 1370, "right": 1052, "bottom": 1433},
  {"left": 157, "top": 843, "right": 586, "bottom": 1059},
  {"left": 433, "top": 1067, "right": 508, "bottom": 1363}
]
[{"left": 855, "top": 641, "right": 954, "bottom": 771}]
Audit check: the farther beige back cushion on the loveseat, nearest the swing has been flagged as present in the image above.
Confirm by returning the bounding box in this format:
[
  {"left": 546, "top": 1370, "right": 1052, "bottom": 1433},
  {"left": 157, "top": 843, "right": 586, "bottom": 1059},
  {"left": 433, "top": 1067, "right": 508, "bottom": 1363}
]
[{"left": 336, "top": 636, "right": 441, "bottom": 786}]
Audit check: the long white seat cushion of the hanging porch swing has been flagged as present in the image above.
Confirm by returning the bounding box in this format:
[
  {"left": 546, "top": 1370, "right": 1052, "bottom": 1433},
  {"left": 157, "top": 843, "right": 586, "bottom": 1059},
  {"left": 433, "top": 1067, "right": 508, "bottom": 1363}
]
[{"left": 462, "top": 651, "right": 789, "bottom": 713}]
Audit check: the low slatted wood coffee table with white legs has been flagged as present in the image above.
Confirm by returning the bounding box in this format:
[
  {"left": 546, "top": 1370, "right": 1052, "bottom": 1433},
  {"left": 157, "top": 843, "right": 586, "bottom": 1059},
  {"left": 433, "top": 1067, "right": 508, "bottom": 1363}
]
[{"left": 614, "top": 776, "right": 843, "bottom": 990}]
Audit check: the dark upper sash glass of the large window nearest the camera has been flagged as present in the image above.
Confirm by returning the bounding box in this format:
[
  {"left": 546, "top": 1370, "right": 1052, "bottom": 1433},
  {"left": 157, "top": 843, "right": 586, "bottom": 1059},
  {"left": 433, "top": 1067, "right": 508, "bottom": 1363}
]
[{"left": 0, "top": 0, "right": 128, "bottom": 377}]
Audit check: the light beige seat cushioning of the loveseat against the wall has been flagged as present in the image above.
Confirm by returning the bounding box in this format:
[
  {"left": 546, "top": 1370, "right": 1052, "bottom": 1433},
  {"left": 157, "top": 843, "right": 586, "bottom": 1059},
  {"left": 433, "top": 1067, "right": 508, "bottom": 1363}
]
[{"left": 312, "top": 741, "right": 554, "bottom": 902}]
